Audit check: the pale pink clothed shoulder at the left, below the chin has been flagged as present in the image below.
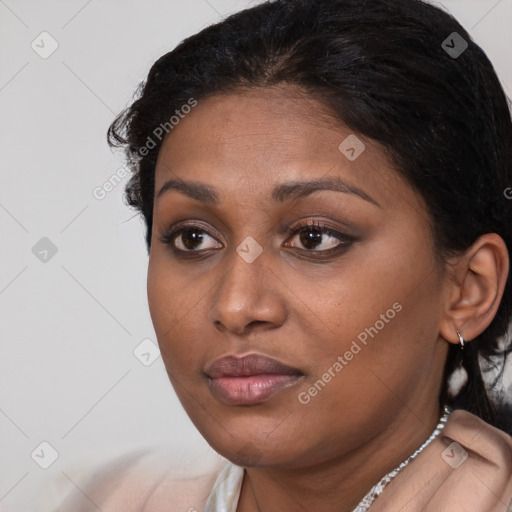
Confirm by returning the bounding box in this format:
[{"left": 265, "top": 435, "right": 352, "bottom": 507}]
[{"left": 54, "top": 450, "right": 228, "bottom": 512}]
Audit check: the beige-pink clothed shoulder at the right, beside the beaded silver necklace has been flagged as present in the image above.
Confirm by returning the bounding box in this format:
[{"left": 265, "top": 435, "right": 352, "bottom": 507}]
[{"left": 374, "top": 409, "right": 512, "bottom": 512}]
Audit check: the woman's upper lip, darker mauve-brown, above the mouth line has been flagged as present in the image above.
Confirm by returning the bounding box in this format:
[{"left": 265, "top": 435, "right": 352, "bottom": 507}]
[{"left": 205, "top": 354, "right": 302, "bottom": 379}]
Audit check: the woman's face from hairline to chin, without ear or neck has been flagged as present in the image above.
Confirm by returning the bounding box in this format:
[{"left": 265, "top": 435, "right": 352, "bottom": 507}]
[{"left": 148, "top": 87, "right": 448, "bottom": 468}]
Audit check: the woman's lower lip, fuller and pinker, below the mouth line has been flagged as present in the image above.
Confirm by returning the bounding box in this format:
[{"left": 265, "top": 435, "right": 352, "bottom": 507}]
[{"left": 210, "top": 374, "right": 302, "bottom": 405}]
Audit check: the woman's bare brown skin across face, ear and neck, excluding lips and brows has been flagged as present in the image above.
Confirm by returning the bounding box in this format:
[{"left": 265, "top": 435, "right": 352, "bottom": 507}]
[{"left": 148, "top": 86, "right": 508, "bottom": 512}]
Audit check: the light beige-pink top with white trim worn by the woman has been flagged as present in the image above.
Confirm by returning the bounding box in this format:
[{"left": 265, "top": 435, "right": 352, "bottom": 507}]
[{"left": 51, "top": 410, "right": 512, "bottom": 512}]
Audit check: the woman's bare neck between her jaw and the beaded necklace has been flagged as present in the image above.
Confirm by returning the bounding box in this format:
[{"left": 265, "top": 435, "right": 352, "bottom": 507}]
[{"left": 237, "top": 404, "right": 442, "bottom": 512}]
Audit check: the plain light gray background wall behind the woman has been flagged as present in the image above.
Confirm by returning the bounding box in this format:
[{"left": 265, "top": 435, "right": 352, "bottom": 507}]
[{"left": 0, "top": 0, "right": 512, "bottom": 511}]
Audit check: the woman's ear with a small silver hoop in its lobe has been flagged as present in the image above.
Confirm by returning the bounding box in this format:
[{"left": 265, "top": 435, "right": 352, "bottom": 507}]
[{"left": 439, "top": 233, "right": 509, "bottom": 344}]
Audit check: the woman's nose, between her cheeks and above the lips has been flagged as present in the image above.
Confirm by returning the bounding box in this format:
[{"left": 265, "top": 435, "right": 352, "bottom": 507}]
[{"left": 209, "top": 244, "right": 287, "bottom": 335}]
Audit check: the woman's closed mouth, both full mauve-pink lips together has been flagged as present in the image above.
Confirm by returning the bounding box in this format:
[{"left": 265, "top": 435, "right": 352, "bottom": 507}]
[{"left": 204, "top": 354, "right": 304, "bottom": 405}]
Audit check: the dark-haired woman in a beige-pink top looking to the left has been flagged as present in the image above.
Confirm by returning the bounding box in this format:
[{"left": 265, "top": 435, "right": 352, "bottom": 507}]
[{"left": 55, "top": 0, "right": 512, "bottom": 512}]
